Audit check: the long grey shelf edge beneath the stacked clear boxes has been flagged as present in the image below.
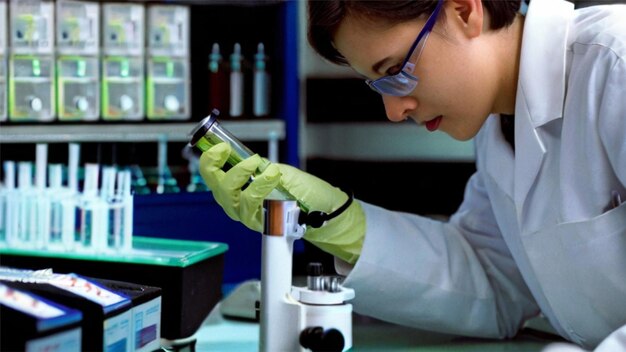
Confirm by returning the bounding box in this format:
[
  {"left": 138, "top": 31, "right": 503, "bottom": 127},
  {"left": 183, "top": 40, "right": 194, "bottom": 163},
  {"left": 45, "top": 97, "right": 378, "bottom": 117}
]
[{"left": 0, "top": 119, "right": 286, "bottom": 143}]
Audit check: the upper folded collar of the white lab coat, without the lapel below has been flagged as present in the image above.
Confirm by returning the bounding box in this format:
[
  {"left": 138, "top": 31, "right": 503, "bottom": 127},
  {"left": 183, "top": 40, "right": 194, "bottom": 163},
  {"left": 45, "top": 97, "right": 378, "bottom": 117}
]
[{"left": 516, "top": 0, "right": 574, "bottom": 128}]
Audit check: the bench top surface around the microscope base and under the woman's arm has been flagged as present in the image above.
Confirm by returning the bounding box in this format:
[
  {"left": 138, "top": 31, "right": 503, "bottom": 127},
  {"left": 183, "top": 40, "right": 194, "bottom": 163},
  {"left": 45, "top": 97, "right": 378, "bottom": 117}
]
[{"left": 189, "top": 303, "right": 561, "bottom": 352}]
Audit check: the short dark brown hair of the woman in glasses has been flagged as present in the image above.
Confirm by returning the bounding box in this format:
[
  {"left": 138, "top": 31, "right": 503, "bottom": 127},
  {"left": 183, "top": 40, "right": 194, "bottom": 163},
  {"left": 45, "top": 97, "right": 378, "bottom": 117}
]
[{"left": 308, "top": 0, "right": 521, "bottom": 65}]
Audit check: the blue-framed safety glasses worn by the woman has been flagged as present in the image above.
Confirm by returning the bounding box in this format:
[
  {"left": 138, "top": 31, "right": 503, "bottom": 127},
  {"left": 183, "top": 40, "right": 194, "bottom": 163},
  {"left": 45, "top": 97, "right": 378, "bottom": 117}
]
[{"left": 365, "top": 0, "right": 443, "bottom": 97}]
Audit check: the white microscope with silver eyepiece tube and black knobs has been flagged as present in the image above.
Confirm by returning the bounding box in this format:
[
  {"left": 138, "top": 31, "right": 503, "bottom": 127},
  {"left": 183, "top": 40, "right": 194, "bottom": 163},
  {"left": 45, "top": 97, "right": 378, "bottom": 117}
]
[{"left": 260, "top": 200, "right": 354, "bottom": 352}]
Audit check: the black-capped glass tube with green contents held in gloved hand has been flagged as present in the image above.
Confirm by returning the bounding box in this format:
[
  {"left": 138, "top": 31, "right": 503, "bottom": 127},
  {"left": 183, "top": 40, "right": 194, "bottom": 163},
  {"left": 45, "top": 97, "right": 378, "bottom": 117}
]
[{"left": 189, "top": 109, "right": 309, "bottom": 212}]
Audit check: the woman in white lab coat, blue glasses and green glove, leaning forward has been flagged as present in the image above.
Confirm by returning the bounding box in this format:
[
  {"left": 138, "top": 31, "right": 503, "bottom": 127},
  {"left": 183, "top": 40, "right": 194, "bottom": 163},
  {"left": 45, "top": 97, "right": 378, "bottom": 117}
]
[{"left": 201, "top": 0, "right": 626, "bottom": 348}]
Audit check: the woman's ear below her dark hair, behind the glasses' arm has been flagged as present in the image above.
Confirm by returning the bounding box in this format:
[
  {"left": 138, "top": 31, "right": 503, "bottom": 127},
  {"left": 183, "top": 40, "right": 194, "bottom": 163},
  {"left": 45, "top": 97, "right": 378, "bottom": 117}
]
[{"left": 438, "top": 0, "right": 482, "bottom": 38}]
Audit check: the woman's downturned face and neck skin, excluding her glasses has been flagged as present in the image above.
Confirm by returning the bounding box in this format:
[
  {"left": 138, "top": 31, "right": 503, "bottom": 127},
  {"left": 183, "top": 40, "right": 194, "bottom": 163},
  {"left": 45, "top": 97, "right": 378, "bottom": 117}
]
[{"left": 334, "top": 2, "right": 501, "bottom": 140}]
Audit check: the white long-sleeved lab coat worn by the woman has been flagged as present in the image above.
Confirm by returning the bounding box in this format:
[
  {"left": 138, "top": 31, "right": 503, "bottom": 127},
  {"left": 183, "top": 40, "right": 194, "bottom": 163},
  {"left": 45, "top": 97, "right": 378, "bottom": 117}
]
[{"left": 338, "top": 0, "right": 626, "bottom": 348}]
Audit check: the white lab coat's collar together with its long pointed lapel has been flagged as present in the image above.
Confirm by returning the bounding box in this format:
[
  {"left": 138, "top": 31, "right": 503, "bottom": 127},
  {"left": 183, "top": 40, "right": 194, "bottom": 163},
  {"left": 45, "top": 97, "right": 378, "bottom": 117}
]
[{"left": 513, "top": 0, "right": 574, "bottom": 224}]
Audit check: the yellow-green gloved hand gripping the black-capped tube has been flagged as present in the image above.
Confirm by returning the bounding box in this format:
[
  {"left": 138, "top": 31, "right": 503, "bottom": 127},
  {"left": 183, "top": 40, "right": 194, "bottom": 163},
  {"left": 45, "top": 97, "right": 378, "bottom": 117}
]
[{"left": 200, "top": 143, "right": 365, "bottom": 264}]
